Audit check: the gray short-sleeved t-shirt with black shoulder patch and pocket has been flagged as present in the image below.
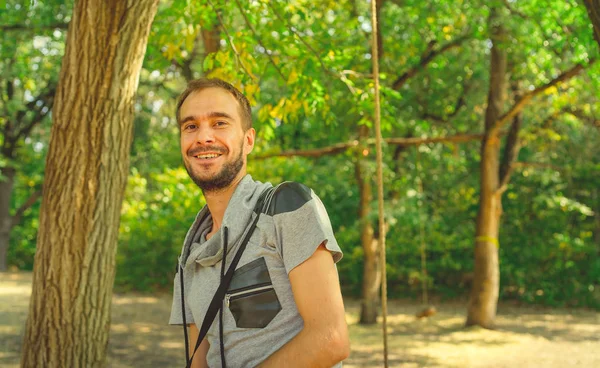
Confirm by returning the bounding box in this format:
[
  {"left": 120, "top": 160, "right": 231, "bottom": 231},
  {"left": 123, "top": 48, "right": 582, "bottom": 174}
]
[{"left": 169, "top": 175, "right": 342, "bottom": 368}]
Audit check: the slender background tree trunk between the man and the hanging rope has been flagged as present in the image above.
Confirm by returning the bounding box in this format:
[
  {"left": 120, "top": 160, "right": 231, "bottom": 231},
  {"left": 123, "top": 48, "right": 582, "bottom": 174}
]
[{"left": 355, "top": 126, "right": 381, "bottom": 324}]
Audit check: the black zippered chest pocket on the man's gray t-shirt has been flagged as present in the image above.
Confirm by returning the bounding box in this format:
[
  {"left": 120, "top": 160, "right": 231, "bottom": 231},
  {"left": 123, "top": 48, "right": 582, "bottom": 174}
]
[{"left": 225, "top": 258, "right": 281, "bottom": 328}]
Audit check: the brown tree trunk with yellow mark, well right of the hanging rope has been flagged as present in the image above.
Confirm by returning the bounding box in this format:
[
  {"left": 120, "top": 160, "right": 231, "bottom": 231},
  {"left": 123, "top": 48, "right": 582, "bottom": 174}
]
[{"left": 466, "top": 9, "right": 507, "bottom": 328}]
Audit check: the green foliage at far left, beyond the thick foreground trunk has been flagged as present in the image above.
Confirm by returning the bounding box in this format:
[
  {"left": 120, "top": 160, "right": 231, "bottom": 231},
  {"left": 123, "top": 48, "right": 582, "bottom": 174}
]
[{"left": 0, "top": 0, "right": 71, "bottom": 270}]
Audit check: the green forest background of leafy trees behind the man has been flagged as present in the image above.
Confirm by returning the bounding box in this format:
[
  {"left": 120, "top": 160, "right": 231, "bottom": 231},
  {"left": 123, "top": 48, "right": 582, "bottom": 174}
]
[{"left": 0, "top": 0, "right": 600, "bottom": 330}]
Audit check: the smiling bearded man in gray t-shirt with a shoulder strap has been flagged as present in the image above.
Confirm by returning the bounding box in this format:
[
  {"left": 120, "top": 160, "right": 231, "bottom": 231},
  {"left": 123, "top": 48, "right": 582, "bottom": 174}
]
[{"left": 169, "top": 79, "right": 349, "bottom": 367}]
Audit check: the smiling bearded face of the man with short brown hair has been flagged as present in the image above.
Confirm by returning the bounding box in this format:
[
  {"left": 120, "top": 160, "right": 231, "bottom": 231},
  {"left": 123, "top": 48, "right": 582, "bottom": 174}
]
[{"left": 179, "top": 87, "right": 255, "bottom": 193}]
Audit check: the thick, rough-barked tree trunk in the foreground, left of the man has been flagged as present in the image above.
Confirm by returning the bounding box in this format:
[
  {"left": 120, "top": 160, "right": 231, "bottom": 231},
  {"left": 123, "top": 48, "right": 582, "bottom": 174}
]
[{"left": 21, "top": 0, "right": 158, "bottom": 368}]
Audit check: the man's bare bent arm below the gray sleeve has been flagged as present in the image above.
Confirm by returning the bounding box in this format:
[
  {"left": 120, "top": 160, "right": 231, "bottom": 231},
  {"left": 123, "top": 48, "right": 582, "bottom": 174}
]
[{"left": 259, "top": 244, "right": 350, "bottom": 368}]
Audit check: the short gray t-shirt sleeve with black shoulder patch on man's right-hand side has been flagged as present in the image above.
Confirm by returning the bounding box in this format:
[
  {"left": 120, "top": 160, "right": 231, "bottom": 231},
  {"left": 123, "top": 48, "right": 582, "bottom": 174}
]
[{"left": 271, "top": 182, "right": 342, "bottom": 274}]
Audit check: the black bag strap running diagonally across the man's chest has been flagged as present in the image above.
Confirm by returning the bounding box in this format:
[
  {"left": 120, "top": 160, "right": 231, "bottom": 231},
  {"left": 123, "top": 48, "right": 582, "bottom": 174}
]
[{"left": 179, "top": 187, "right": 276, "bottom": 368}]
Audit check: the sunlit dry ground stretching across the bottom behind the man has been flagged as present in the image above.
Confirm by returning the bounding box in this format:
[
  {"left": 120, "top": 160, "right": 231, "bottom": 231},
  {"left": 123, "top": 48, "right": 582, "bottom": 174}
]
[{"left": 0, "top": 273, "right": 600, "bottom": 368}]
